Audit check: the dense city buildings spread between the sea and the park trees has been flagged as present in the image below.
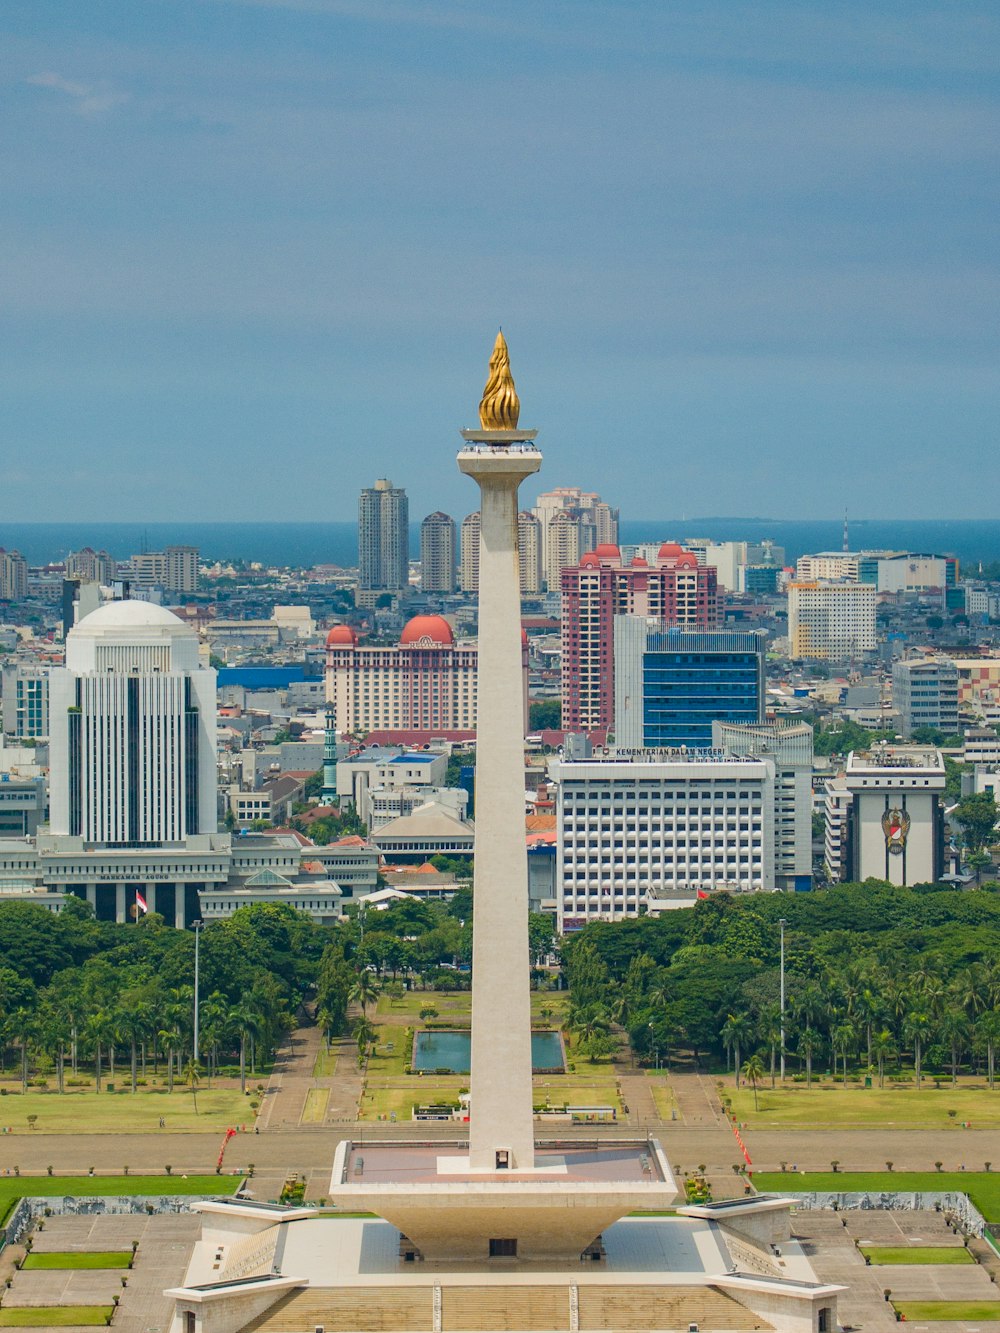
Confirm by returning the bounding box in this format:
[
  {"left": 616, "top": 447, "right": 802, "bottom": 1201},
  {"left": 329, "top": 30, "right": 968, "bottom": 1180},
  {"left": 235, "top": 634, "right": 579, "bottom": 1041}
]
[{"left": 0, "top": 479, "right": 1000, "bottom": 932}]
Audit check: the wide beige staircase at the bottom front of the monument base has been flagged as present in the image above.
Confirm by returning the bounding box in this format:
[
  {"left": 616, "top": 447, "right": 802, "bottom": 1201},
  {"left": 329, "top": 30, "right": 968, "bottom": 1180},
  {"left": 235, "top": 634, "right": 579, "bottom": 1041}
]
[{"left": 244, "top": 1284, "right": 773, "bottom": 1333}]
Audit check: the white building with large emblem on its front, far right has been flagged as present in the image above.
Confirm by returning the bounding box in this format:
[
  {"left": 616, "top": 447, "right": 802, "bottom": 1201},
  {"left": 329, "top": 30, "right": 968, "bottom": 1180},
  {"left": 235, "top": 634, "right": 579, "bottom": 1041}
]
[{"left": 827, "top": 745, "right": 947, "bottom": 886}]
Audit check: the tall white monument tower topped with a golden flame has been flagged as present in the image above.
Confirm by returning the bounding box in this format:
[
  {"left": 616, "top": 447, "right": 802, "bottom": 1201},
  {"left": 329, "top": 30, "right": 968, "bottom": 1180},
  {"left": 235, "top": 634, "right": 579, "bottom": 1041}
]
[{"left": 459, "top": 333, "right": 541, "bottom": 1170}]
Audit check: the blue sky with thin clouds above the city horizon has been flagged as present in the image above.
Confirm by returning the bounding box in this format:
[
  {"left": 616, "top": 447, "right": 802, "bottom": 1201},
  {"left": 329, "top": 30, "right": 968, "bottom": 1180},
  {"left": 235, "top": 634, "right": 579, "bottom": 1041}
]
[{"left": 0, "top": 0, "right": 1000, "bottom": 519}]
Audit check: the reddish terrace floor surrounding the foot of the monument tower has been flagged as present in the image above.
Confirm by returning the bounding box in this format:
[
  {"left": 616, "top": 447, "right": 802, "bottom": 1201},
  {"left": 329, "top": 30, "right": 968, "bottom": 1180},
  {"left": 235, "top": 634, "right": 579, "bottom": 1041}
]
[{"left": 344, "top": 1142, "right": 663, "bottom": 1188}]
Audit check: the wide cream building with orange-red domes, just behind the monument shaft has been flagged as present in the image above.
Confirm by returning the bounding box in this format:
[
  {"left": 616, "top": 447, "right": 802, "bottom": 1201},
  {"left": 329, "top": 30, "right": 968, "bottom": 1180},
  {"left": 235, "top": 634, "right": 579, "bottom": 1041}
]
[{"left": 327, "top": 616, "right": 528, "bottom": 745}]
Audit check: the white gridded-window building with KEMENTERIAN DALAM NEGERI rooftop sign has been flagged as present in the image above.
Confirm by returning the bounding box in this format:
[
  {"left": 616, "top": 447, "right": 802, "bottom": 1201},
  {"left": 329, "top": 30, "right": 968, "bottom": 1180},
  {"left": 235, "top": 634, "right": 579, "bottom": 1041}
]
[{"left": 549, "top": 750, "right": 775, "bottom": 932}]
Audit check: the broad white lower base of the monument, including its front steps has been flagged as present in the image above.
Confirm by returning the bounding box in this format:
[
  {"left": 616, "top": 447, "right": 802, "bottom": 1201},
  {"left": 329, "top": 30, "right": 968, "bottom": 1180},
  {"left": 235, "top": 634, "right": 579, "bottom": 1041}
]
[{"left": 168, "top": 1198, "right": 840, "bottom": 1333}]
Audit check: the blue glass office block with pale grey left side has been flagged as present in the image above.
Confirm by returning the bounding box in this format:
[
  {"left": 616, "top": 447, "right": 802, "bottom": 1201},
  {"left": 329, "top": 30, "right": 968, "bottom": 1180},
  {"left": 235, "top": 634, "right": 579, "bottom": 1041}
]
[{"left": 615, "top": 616, "right": 764, "bottom": 749}]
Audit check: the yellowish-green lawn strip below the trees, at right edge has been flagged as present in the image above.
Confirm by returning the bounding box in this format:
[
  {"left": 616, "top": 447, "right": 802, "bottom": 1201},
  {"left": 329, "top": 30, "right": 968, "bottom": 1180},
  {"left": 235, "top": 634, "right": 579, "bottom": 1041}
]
[{"left": 724, "top": 1081, "right": 1000, "bottom": 1129}]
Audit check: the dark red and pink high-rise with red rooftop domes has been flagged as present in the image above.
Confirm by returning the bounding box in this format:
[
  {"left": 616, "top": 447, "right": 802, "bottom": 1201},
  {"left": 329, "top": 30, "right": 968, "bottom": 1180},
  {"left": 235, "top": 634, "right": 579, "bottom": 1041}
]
[{"left": 561, "top": 543, "right": 720, "bottom": 732}]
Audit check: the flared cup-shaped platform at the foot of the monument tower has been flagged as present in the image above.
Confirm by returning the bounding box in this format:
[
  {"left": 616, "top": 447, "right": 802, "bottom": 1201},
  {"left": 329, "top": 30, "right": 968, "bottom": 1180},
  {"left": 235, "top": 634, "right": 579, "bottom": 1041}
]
[{"left": 329, "top": 1138, "right": 677, "bottom": 1262}]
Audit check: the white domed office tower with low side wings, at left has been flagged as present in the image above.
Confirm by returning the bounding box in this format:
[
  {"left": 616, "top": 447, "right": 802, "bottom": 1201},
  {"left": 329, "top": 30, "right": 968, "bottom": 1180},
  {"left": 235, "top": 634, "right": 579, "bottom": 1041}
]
[{"left": 0, "top": 601, "right": 377, "bottom": 926}]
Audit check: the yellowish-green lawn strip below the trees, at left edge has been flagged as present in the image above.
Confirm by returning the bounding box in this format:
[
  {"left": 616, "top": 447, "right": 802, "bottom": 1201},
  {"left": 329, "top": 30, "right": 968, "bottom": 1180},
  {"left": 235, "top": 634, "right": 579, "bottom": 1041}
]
[{"left": 0, "top": 1084, "right": 253, "bottom": 1134}]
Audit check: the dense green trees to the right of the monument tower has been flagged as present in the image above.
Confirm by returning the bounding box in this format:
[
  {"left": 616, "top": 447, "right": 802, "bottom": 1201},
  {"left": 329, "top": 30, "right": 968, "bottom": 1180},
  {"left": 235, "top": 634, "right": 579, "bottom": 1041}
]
[{"left": 563, "top": 880, "right": 1000, "bottom": 1088}]
